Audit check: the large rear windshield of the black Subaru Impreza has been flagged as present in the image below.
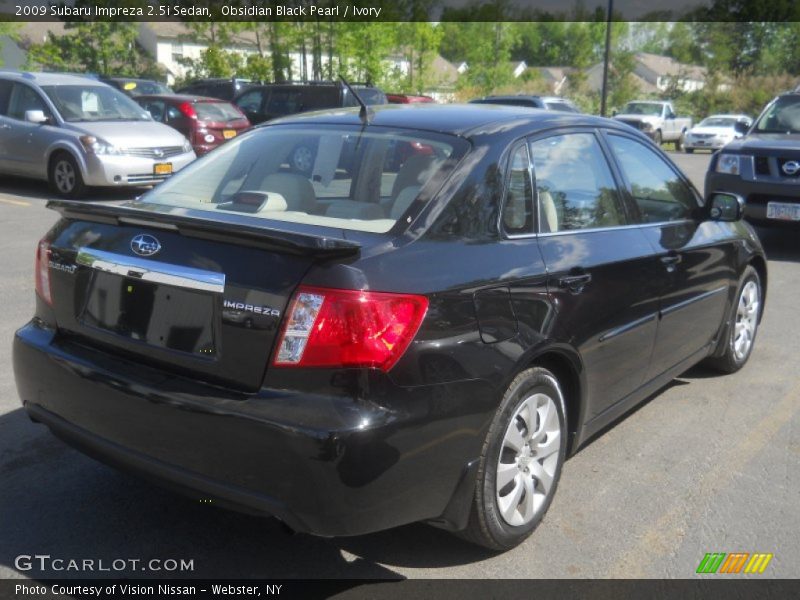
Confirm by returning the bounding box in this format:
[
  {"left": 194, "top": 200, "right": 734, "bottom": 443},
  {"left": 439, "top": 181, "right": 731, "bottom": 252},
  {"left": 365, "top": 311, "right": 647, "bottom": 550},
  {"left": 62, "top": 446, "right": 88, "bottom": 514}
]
[{"left": 142, "top": 125, "right": 469, "bottom": 233}]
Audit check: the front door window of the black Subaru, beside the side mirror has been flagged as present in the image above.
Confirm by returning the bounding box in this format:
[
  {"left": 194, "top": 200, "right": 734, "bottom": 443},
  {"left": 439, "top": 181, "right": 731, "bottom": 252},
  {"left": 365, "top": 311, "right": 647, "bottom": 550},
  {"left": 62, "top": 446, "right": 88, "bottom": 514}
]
[{"left": 608, "top": 135, "right": 697, "bottom": 223}]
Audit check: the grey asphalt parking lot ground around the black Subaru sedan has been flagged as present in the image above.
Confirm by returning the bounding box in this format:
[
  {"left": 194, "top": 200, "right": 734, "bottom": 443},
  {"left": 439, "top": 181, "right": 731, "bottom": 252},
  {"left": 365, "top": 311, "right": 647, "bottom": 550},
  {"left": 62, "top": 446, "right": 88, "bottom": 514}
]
[{"left": 0, "top": 154, "right": 800, "bottom": 579}]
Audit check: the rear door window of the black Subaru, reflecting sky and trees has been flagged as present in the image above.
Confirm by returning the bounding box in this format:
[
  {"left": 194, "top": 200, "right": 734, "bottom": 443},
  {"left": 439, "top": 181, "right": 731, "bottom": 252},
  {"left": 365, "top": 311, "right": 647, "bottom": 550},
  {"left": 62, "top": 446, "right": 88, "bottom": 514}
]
[{"left": 531, "top": 133, "right": 627, "bottom": 233}]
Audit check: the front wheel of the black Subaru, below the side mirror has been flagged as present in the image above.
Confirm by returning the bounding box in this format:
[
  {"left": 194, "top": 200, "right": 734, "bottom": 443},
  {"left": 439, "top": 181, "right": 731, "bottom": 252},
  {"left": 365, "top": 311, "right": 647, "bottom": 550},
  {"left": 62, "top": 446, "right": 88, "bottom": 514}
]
[{"left": 706, "top": 266, "right": 763, "bottom": 373}]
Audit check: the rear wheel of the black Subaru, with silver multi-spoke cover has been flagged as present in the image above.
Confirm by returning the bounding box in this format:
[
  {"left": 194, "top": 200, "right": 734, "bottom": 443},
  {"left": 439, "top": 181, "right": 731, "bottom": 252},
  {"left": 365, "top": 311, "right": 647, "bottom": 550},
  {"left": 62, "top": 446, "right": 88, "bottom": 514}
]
[{"left": 459, "top": 367, "right": 567, "bottom": 551}]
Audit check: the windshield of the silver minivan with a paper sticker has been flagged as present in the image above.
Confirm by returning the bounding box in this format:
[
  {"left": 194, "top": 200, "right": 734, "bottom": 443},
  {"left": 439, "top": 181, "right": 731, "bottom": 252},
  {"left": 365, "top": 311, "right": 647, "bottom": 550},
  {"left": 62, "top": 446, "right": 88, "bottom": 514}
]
[{"left": 42, "top": 85, "right": 150, "bottom": 123}]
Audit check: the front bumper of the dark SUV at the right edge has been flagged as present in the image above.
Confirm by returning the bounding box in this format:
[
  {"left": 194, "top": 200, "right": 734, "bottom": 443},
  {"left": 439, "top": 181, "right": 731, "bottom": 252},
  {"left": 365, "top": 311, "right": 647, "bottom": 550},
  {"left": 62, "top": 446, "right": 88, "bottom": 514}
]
[{"left": 705, "top": 172, "right": 800, "bottom": 226}]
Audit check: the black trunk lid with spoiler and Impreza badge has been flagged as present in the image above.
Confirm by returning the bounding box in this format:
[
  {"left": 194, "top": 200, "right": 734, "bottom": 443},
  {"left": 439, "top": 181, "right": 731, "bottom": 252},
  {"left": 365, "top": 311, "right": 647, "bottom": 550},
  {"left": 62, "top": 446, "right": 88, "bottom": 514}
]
[{"left": 40, "top": 201, "right": 359, "bottom": 391}]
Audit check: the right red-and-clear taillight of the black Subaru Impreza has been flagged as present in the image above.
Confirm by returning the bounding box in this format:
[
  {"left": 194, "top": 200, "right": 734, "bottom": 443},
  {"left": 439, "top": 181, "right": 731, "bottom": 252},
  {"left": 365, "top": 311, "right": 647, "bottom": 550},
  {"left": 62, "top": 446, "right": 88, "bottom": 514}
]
[{"left": 273, "top": 286, "right": 428, "bottom": 371}]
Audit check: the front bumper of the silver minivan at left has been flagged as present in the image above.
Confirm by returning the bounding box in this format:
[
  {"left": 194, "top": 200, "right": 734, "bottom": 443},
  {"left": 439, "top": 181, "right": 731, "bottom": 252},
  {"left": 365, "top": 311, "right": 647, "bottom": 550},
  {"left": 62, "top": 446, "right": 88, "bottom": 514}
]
[{"left": 83, "top": 152, "right": 196, "bottom": 187}]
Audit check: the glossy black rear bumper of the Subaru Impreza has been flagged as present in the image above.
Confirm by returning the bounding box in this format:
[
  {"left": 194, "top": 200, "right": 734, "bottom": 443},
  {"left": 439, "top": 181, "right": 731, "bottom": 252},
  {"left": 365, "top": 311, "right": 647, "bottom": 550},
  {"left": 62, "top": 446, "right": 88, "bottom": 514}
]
[{"left": 13, "top": 321, "right": 486, "bottom": 536}]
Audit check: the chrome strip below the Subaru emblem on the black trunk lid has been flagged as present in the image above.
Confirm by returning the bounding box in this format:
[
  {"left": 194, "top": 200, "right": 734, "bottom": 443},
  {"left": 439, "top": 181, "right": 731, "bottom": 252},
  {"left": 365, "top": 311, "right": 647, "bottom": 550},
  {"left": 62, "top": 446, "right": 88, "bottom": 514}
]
[{"left": 75, "top": 247, "right": 225, "bottom": 294}]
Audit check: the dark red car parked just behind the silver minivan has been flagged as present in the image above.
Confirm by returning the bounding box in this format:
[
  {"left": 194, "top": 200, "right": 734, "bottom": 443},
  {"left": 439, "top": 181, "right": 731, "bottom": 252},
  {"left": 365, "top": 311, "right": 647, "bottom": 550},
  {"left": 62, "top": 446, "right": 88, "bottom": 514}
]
[{"left": 134, "top": 94, "right": 250, "bottom": 156}]
